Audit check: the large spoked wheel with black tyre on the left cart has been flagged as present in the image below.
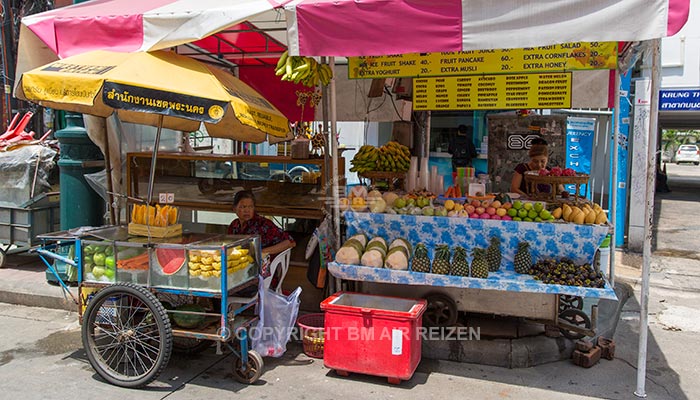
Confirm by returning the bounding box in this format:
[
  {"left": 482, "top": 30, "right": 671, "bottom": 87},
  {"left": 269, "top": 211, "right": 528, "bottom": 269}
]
[{"left": 82, "top": 283, "right": 173, "bottom": 388}]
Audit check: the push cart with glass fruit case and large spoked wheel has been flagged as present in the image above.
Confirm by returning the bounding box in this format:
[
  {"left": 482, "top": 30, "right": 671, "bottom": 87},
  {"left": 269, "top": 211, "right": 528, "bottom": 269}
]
[{"left": 37, "top": 226, "right": 263, "bottom": 387}]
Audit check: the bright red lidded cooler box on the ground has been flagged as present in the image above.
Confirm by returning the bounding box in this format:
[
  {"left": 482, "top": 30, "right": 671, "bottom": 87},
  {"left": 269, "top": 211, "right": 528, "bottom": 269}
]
[{"left": 321, "top": 292, "right": 427, "bottom": 384}]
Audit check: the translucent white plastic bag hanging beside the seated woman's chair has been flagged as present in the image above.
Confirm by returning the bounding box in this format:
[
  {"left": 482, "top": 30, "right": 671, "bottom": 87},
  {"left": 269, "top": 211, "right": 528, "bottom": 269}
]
[{"left": 251, "top": 279, "right": 301, "bottom": 357}]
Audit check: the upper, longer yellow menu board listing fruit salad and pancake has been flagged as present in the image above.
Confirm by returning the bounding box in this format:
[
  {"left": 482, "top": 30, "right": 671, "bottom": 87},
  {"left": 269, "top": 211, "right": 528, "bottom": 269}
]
[{"left": 348, "top": 42, "right": 617, "bottom": 79}]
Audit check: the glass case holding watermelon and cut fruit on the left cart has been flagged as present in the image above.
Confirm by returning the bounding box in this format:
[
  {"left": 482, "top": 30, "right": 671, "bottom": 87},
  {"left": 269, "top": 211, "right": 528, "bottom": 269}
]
[{"left": 80, "top": 226, "right": 262, "bottom": 294}]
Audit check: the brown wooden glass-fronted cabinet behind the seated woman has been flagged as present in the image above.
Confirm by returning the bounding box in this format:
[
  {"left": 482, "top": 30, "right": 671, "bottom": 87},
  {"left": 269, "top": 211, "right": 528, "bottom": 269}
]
[{"left": 127, "top": 153, "right": 345, "bottom": 219}]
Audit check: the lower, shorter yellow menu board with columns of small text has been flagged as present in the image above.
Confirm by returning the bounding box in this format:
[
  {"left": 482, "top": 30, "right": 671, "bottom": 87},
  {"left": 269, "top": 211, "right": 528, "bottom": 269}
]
[{"left": 413, "top": 72, "right": 571, "bottom": 110}]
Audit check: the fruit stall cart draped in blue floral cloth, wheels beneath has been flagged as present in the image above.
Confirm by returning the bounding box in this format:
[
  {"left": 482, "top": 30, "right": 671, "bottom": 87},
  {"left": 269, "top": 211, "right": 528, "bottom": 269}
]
[{"left": 328, "top": 212, "right": 617, "bottom": 339}]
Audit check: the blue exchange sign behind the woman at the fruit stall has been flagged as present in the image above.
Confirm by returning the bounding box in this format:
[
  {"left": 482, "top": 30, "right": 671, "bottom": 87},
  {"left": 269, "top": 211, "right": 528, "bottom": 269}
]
[{"left": 564, "top": 117, "right": 596, "bottom": 196}]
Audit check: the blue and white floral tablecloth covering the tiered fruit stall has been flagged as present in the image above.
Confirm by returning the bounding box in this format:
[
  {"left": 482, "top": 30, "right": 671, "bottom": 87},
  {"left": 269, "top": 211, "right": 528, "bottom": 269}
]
[{"left": 340, "top": 212, "right": 617, "bottom": 299}]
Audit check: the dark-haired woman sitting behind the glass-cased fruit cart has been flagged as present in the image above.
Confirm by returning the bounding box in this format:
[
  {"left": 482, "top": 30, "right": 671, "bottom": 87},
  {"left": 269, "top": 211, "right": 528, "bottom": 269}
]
[{"left": 228, "top": 190, "right": 296, "bottom": 258}]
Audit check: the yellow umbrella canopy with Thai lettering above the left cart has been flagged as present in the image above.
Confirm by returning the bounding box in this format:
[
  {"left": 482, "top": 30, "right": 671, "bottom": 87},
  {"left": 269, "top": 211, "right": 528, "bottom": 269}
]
[{"left": 15, "top": 50, "right": 290, "bottom": 143}]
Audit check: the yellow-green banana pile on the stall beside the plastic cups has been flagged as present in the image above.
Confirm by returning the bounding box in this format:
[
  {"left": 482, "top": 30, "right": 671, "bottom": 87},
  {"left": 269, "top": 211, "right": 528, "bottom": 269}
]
[{"left": 350, "top": 141, "right": 411, "bottom": 174}]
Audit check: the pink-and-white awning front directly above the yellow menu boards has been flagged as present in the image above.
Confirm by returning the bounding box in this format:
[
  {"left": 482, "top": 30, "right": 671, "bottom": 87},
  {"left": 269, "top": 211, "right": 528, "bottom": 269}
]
[{"left": 285, "top": 0, "right": 690, "bottom": 56}]
